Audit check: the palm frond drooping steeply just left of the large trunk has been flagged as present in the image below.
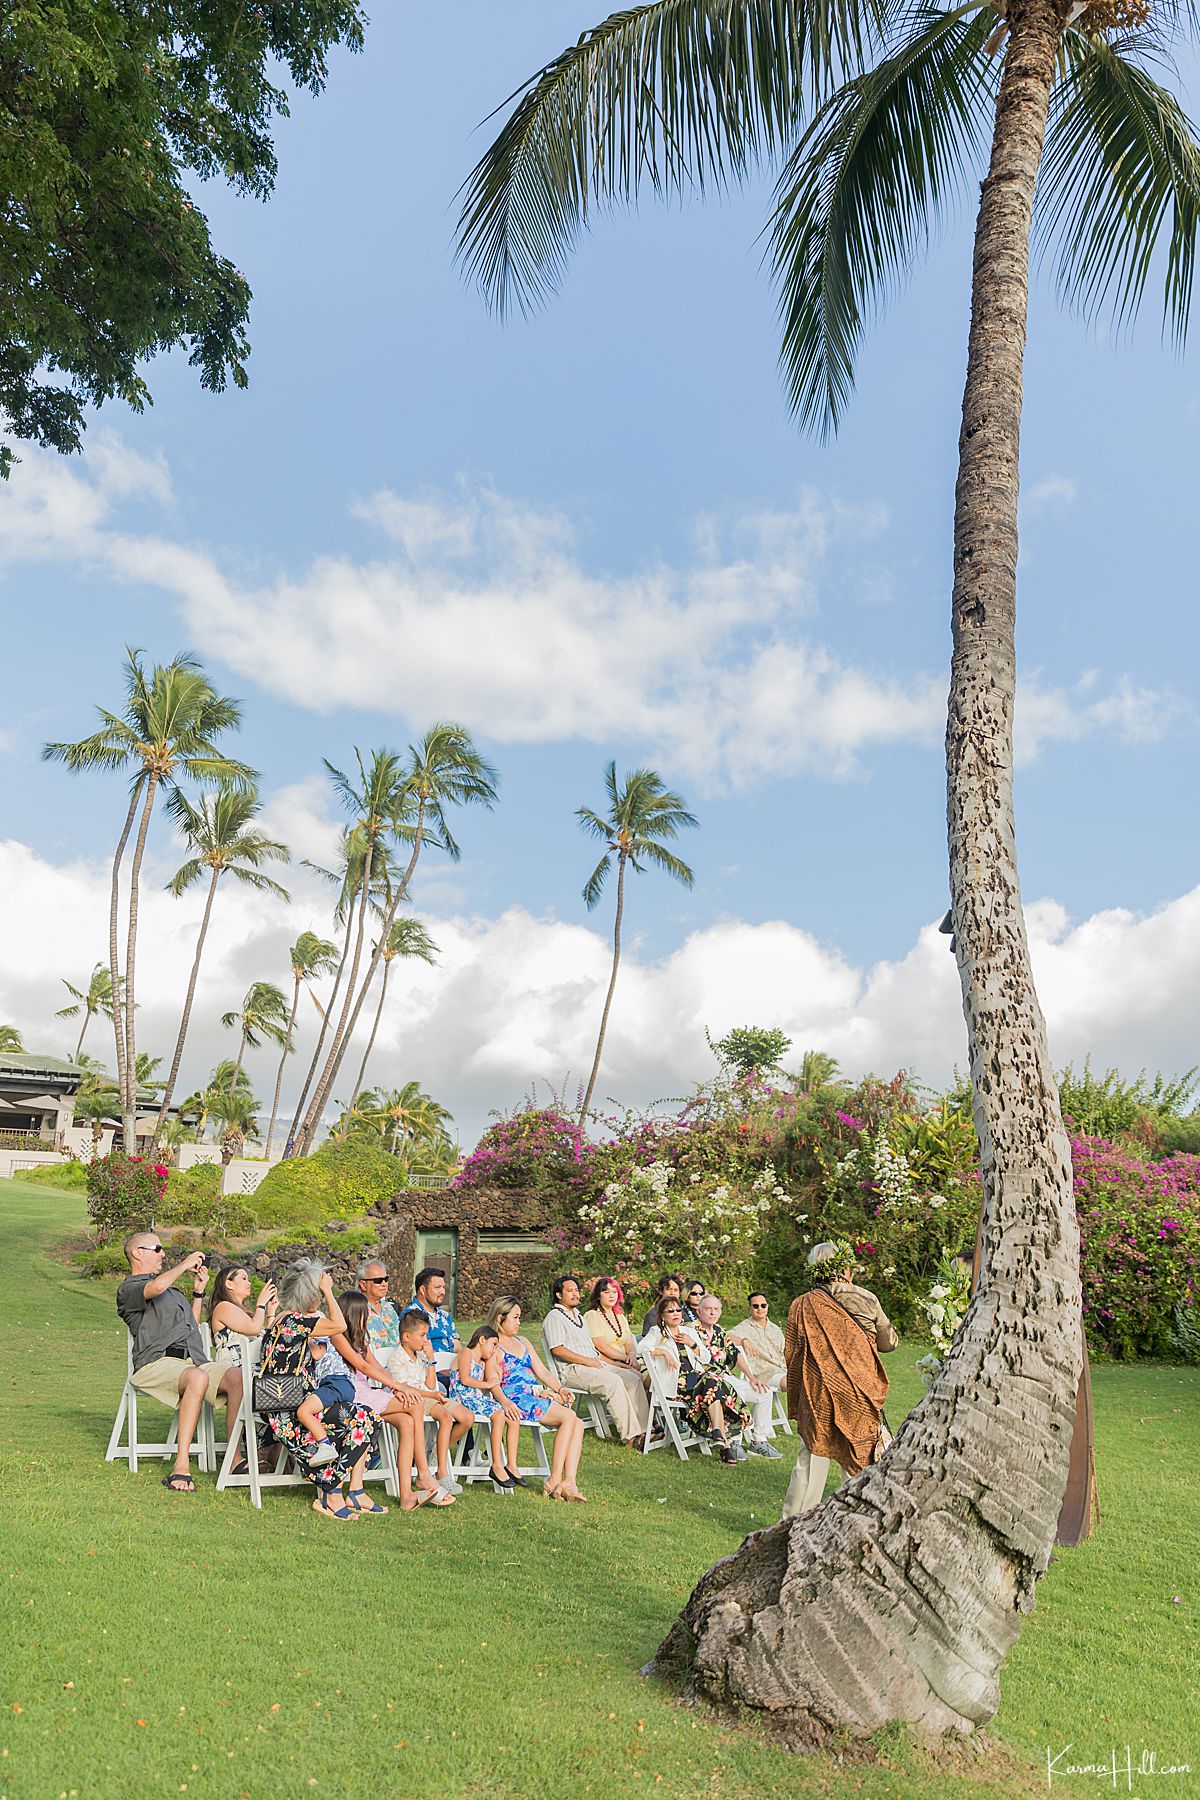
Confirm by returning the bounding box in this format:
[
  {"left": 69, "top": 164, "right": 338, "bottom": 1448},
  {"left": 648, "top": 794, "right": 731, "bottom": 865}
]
[{"left": 770, "top": 5, "right": 999, "bottom": 436}]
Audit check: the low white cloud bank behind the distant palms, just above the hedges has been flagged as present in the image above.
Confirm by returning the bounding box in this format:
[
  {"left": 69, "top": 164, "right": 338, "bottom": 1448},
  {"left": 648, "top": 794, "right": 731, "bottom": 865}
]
[{"left": 0, "top": 824, "right": 1200, "bottom": 1141}]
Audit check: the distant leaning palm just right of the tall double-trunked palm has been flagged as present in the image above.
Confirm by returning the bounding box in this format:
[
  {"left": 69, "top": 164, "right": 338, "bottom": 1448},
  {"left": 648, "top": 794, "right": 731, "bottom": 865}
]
[{"left": 151, "top": 785, "right": 290, "bottom": 1150}]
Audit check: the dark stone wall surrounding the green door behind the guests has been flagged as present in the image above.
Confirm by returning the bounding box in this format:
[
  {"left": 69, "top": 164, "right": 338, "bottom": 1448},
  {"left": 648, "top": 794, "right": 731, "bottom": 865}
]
[{"left": 369, "top": 1188, "right": 556, "bottom": 1319}]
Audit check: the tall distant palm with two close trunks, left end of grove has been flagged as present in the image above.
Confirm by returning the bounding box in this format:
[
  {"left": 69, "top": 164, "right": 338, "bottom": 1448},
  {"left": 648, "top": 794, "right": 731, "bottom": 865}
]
[{"left": 41, "top": 646, "right": 254, "bottom": 1143}]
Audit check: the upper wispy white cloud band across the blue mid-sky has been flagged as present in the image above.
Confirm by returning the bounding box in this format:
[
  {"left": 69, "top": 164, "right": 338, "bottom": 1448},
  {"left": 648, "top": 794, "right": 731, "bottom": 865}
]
[{"left": 0, "top": 443, "right": 1182, "bottom": 788}]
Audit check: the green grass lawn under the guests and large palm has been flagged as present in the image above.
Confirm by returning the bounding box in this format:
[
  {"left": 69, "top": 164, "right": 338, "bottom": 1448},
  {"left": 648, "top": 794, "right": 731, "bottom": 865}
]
[{"left": 0, "top": 1181, "right": 1200, "bottom": 1800}]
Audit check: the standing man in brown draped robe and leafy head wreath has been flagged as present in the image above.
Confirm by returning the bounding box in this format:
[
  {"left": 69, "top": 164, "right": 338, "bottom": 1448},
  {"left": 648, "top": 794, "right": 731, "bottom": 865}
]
[{"left": 783, "top": 1238, "right": 900, "bottom": 1519}]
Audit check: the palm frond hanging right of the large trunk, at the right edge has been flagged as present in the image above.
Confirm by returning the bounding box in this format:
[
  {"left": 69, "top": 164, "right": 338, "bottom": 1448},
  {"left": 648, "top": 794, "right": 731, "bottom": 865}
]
[{"left": 1038, "top": 31, "right": 1200, "bottom": 344}]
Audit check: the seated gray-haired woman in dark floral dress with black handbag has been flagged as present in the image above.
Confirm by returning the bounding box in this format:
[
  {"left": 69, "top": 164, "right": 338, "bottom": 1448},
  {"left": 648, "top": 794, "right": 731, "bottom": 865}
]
[{"left": 261, "top": 1256, "right": 383, "bottom": 1523}]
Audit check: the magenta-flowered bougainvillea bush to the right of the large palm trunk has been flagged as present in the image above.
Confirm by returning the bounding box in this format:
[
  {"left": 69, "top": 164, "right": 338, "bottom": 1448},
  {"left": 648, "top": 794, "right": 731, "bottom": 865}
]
[{"left": 1070, "top": 1138, "right": 1200, "bottom": 1357}]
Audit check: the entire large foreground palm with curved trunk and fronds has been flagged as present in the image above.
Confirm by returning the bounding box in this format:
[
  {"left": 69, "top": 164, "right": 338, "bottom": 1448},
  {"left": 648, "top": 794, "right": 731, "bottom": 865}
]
[{"left": 461, "top": 0, "right": 1200, "bottom": 1735}]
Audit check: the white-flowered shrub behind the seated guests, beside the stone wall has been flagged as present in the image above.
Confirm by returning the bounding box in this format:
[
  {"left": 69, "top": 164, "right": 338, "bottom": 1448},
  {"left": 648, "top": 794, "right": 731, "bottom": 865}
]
[{"left": 576, "top": 1163, "right": 793, "bottom": 1298}]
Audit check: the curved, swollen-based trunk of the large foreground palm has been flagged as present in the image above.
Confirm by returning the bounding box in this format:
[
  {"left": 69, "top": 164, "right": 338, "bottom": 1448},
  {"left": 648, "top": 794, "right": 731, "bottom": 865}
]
[{"left": 657, "top": 0, "right": 1081, "bottom": 1742}]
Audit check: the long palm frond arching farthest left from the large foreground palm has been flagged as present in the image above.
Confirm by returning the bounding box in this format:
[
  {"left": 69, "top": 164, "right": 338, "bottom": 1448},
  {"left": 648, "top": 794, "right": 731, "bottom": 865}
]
[{"left": 457, "top": 0, "right": 887, "bottom": 313}]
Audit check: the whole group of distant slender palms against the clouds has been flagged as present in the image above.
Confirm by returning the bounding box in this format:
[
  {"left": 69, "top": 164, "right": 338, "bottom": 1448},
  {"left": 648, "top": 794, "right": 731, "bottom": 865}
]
[{"left": 23, "top": 650, "right": 696, "bottom": 1175}]
